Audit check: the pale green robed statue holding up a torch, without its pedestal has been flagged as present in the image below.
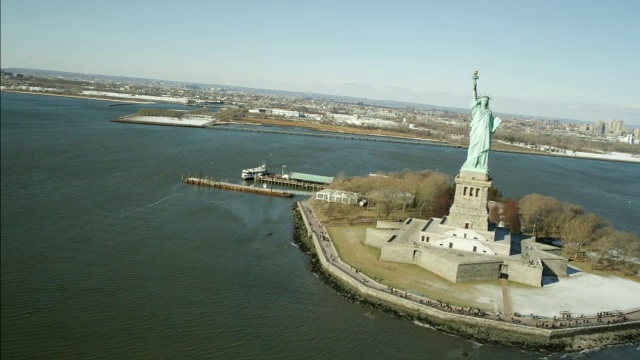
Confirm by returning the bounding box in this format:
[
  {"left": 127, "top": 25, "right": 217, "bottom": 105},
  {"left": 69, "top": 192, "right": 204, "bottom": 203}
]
[{"left": 461, "top": 70, "right": 502, "bottom": 174}]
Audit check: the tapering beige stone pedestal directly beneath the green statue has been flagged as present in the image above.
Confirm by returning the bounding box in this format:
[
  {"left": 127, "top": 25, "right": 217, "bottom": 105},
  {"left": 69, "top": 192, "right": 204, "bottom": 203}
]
[{"left": 447, "top": 171, "right": 491, "bottom": 230}]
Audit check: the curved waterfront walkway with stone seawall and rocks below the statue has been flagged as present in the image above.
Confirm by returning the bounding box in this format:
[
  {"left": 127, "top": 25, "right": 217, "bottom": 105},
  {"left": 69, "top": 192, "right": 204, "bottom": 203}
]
[{"left": 294, "top": 201, "right": 640, "bottom": 352}]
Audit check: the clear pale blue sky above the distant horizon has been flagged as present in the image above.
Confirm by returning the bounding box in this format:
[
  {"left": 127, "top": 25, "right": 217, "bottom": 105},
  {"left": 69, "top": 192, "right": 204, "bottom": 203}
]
[{"left": 0, "top": 0, "right": 640, "bottom": 127}]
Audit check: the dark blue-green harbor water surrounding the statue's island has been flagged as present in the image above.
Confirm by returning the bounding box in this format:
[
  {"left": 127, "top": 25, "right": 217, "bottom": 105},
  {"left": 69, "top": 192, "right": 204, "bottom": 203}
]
[{"left": 0, "top": 93, "right": 640, "bottom": 359}]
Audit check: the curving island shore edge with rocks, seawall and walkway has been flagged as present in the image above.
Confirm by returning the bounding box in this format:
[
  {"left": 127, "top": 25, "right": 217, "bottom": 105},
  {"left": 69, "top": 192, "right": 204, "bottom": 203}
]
[{"left": 293, "top": 202, "right": 640, "bottom": 352}]
